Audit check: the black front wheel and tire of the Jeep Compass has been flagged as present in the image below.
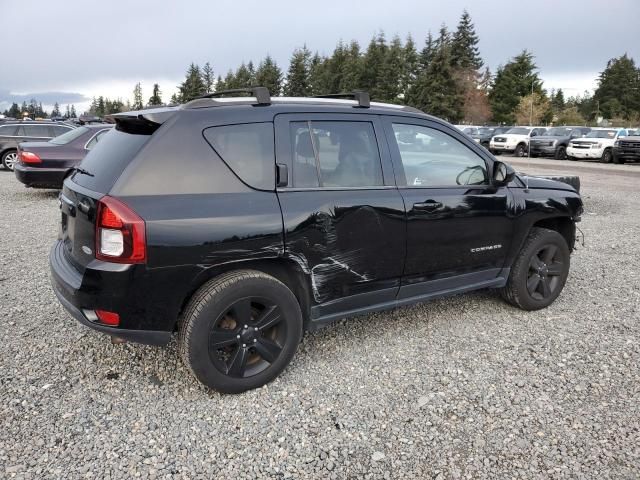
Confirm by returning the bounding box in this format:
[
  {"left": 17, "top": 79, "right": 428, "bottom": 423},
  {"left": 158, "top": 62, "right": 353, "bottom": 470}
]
[{"left": 500, "top": 227, "right": 571, "bottom": 310}]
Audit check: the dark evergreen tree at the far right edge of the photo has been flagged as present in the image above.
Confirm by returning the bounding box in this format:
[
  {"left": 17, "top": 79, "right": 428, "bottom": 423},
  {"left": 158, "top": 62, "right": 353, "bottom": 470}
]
[{"left": 593, "top": 53, "right": 640, "bottom": 120}]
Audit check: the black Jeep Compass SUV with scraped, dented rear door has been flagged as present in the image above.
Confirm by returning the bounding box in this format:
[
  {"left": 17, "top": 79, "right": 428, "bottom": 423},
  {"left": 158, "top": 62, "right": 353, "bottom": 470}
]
[{"left": 50, "top": 88, "right": 582, "bottom": 392}]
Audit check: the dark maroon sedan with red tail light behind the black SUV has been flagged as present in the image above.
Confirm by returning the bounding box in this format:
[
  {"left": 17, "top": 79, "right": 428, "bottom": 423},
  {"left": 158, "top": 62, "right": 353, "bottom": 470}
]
[{"left": 13, "top": 125, "right": 112, "bottom": 188}]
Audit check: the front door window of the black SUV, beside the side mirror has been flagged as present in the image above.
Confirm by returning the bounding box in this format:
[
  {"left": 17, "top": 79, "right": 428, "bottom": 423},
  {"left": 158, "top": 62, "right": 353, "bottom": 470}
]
[{"left": 393, "top": 123, "right": 489, "bottom": 187}]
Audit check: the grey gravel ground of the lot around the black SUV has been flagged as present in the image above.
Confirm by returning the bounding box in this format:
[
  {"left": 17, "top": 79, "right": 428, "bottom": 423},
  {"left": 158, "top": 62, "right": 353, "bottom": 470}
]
[{"left": 0, "top": 159, "right": 640, "bottom": 479}]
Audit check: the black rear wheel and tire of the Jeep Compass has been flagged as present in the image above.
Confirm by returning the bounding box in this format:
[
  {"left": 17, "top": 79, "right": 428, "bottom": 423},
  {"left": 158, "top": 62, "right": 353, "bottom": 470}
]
[{"left": 178, "top": 270, "right": 302, "bottom": 393}]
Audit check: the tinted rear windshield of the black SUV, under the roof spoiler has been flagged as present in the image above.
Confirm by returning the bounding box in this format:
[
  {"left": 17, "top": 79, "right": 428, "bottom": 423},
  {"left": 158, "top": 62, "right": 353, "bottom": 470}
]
[{"left": 72, "top": 128, "right": 151, "bottom": 193}]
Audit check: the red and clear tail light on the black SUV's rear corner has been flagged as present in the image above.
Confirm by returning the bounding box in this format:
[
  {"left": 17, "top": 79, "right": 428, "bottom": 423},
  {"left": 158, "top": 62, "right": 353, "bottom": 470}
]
[{"left": 96, "top": 196, "right": 147, "bottom": 263}]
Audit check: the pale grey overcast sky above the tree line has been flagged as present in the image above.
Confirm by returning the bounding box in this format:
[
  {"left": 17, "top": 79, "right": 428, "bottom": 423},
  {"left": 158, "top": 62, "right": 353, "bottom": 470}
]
[{"left": 0, "top": 0, "right": 640, "bottom": 111}]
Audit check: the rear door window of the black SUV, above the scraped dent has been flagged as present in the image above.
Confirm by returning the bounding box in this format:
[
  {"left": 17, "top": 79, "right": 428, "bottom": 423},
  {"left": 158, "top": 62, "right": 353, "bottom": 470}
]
[{"left": 290, "top": 121, "right": 383, "bottom": 188}]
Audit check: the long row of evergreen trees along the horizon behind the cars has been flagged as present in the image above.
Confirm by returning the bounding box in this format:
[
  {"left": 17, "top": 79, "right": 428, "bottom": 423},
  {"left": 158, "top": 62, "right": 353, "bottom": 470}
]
[{"left": 5, "top": 10, "right": 640, "bottom": 124}]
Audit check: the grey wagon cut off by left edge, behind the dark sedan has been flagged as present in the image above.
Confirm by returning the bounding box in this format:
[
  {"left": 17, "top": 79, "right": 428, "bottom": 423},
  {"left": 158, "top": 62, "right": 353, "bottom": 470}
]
[{"left": 0, "top": 121, "right": 75, "bottom": 170}]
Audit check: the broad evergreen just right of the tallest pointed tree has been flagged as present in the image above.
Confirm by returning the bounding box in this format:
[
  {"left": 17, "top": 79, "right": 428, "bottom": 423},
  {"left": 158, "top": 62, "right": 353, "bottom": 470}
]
[{"left": 489, "top": 50, "right": 543, "bottom": 124}]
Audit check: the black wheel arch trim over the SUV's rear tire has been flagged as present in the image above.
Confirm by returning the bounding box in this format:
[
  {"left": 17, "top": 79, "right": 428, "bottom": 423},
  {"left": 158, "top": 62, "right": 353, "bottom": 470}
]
[{"left": 174, "top": 258, "right": 312, "bottom": 329}]
